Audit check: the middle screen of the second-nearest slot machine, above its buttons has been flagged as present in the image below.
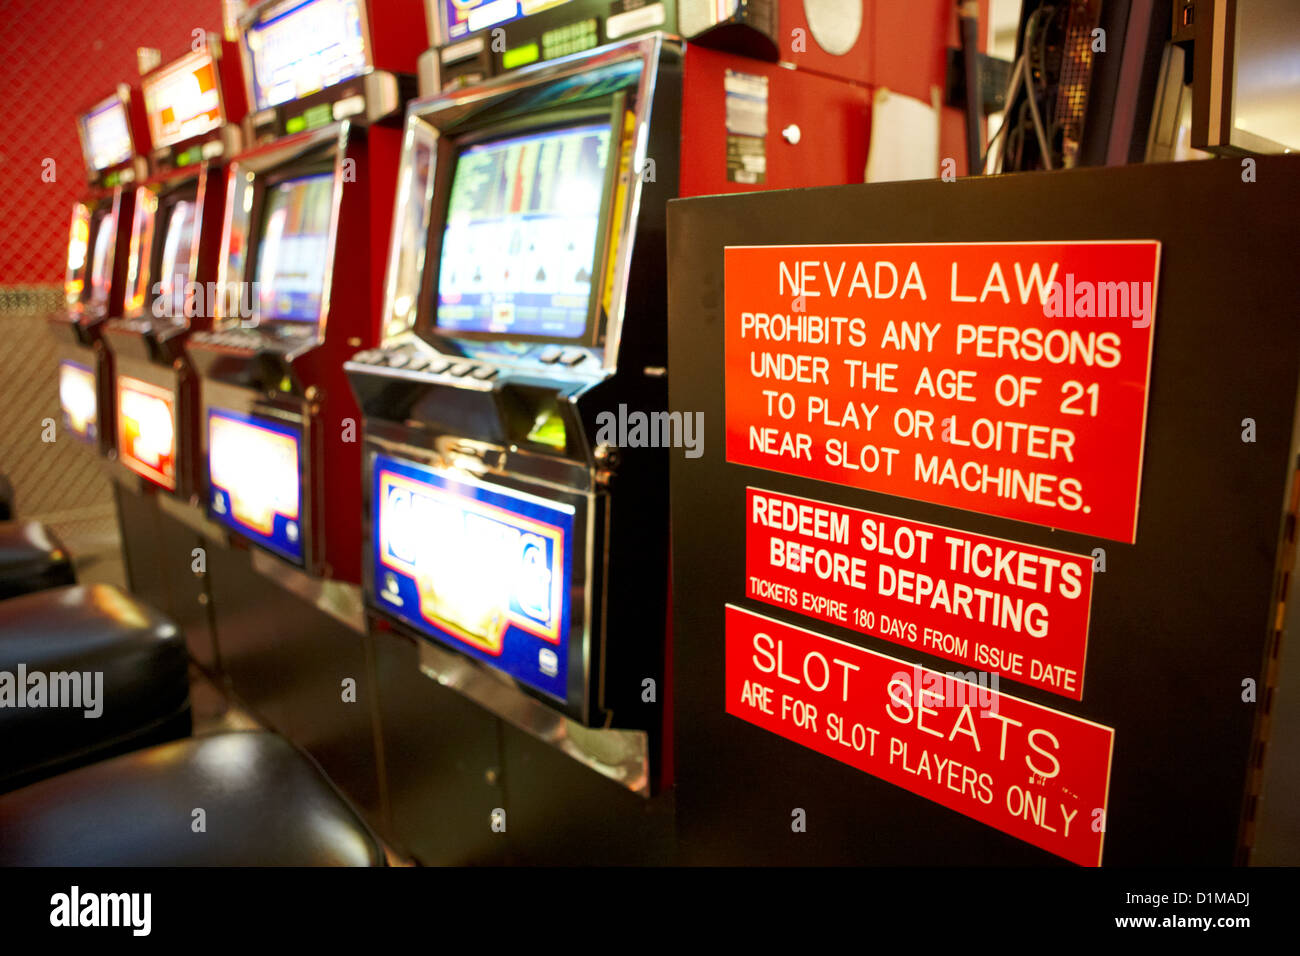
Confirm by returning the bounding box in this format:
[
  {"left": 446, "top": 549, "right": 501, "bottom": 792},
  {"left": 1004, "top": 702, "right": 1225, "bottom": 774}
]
[{"left": 257, "top": 173, "right": 334, "bottom": 329}]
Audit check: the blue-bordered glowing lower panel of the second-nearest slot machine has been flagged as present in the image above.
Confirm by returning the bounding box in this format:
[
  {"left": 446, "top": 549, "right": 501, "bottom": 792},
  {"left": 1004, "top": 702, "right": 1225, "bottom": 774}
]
[{"left": 208, "top": 408, "right": 303, "bottom": 564}]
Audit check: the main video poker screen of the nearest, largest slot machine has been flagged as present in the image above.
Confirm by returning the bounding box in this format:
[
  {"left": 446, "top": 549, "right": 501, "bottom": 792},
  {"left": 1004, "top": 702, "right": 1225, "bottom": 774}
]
[{"left": 437, "top": 126, "right": 610, "bottom": 338}]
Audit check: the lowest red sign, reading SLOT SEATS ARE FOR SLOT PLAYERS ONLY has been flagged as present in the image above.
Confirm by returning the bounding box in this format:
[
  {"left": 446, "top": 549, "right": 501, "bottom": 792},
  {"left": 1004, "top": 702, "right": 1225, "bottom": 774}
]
[{"left": 727, "top": 605, "right": 1115, "bottom": 866}]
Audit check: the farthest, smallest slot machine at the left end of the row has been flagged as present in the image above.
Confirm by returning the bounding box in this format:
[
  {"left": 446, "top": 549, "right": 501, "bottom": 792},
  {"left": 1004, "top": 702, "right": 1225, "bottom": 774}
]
[{"left": 48, "top": 83, "right": 148, "bottom": 454}]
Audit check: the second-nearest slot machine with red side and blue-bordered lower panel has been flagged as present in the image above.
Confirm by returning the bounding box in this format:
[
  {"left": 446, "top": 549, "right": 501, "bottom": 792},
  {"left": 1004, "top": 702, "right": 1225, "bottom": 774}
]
[{"left": 189, "top": 0, "right": 426, "bottom": 581}]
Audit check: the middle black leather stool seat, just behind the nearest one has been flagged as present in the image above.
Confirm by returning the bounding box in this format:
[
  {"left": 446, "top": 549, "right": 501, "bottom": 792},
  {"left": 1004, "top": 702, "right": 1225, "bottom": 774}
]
[{"left": 0, "top": 584, "right": 190, "bottom": 791}]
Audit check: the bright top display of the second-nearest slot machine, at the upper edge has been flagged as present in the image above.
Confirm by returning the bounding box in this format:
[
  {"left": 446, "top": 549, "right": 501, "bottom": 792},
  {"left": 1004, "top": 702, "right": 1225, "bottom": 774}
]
[{"left": 244, "top": 0, "right": 367, "bottom": 109}]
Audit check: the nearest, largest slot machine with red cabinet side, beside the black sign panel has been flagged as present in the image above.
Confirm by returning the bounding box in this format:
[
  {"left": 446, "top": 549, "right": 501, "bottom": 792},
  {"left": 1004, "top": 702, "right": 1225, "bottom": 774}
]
[{"left": 347, "top": 0, "right": 868, "bottom": 786}]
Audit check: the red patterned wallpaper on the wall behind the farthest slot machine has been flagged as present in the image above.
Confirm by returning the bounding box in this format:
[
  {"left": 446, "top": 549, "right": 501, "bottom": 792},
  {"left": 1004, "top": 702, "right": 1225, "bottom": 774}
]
[{"left": 0, "top": 0, "right": 221, "bottom": 286}]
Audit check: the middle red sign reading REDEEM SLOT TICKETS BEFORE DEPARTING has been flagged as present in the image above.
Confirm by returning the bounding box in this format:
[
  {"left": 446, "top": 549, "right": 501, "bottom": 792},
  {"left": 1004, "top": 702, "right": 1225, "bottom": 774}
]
[{"left": 745, "top": 488, "right": 1093, "bottom": 700}]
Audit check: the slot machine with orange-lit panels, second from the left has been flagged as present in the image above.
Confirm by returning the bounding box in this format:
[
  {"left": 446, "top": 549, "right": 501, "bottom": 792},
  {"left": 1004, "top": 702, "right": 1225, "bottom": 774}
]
[{"left": 104, "top": 35, "right": 243, "bottom": 498}]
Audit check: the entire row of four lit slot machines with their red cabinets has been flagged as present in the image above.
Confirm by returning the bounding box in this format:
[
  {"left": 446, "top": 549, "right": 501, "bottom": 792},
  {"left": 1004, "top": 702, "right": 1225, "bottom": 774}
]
[{"left": 51, "top": 0, "right": 870, "bottom": 785}]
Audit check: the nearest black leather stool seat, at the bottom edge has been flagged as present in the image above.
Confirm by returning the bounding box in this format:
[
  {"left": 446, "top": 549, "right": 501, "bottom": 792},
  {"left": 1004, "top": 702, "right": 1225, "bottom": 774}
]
[{"left": 0, "top": 731, "right": 385, "bottom": 866}]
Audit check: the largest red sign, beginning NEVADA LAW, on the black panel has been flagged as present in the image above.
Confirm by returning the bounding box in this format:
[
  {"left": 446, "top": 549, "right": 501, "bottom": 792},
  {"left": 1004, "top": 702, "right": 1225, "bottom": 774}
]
[{"left": 725, "top": 241, "right": 1160, "bottom": 542}]
